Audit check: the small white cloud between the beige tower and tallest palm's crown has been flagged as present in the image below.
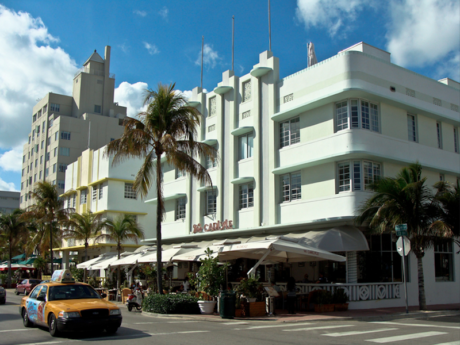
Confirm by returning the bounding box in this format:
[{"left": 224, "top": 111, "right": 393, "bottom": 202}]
[{"left": 114, "top": 81, "right": 148, "bottom": 117}]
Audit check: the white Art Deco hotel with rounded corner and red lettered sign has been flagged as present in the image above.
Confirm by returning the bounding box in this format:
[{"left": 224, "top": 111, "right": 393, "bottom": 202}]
[{"left": 63, "top": 43, "right": 460, "bottom": 308}]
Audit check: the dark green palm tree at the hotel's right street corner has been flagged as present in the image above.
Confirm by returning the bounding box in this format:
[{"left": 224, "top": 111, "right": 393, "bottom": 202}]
[{"left": 356, "top": 163, "right": 452, "bottom": 310}]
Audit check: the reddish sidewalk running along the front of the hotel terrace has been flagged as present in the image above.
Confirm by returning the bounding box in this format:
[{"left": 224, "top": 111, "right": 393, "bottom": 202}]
[{"left": 142, "top": 304, "right": 460, "bottom": 323}]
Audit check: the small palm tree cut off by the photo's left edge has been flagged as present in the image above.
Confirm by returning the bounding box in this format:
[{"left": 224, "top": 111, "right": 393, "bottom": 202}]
[{"left": 0, "top": 209, "right": 27, "bottom": 288}]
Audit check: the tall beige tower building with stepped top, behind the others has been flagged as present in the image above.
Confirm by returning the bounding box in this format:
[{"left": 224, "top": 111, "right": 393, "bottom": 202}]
[{"left": 20, "top": 46, "right": 126, "bottom": 208}]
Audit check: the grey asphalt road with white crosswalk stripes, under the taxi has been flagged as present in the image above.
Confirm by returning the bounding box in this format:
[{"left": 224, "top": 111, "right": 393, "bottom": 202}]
[{"left": 0, "top": 294, "right": 460, "bottom": 345}]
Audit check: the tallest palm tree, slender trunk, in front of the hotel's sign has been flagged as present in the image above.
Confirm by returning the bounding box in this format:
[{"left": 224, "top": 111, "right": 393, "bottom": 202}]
[{"left": 107, "top": 84, "right": 218, "bottom": 293}]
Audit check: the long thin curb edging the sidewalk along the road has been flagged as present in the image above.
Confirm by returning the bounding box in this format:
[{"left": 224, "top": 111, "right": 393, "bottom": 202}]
[{"left": 142, "top": 310, "right": 460, "bottom": 323}]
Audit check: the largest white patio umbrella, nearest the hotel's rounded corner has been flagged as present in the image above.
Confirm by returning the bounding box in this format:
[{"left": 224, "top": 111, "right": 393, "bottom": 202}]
[{"left": 219, "top": 236, "right": 346, "bottom": 275}]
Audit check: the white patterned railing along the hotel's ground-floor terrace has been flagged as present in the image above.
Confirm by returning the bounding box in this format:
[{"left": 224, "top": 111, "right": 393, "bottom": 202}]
[{"left": 231, "top": 282, "right": 402, "bottom": 302}]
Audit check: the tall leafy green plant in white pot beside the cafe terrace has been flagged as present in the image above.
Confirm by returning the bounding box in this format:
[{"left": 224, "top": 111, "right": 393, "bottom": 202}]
[{"left": 191, "top": 248, "right": 228, "bottom": 314}]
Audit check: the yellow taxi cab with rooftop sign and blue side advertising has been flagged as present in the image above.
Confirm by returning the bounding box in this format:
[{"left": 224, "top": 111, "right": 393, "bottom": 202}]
[{"left": 19, "top": 270, "right": 122, "bottom": 337}]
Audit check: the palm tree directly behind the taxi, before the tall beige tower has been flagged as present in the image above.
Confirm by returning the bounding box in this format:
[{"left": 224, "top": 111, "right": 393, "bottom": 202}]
[{"left": 27, "top": 181, "right": 68, "bottom": 275}]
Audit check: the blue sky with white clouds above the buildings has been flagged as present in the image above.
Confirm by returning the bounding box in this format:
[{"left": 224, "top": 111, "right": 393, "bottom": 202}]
[{"left": 0, "top": 0, "right": 460, "bottom": 190}]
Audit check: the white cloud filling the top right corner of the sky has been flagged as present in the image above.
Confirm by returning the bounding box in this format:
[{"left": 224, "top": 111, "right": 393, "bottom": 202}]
[{"left": 386, "top": 0, "right": 460, "bottom": 69}]
